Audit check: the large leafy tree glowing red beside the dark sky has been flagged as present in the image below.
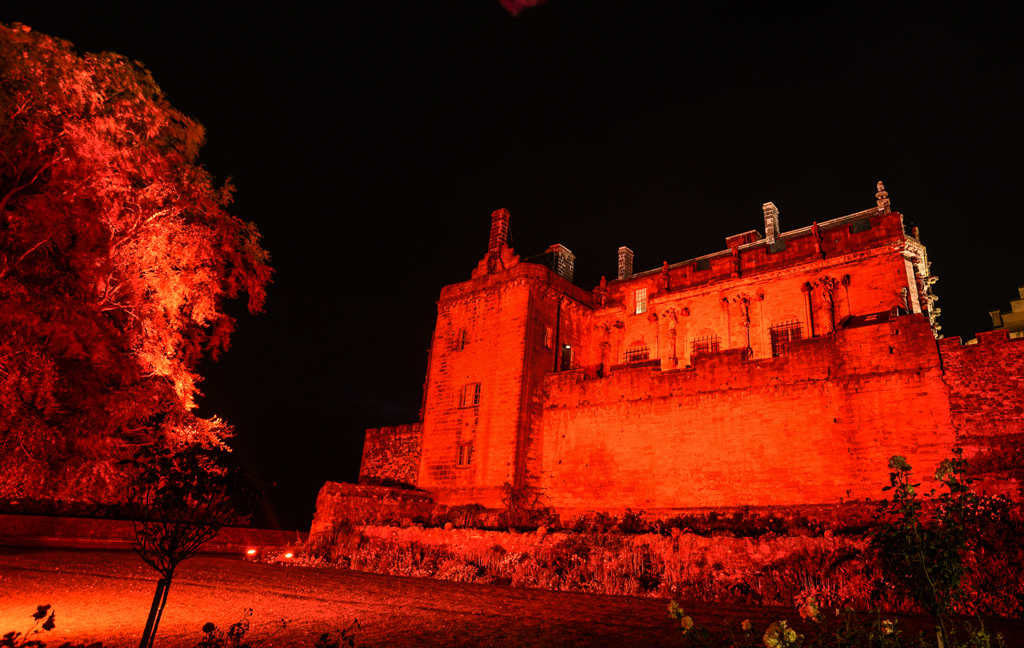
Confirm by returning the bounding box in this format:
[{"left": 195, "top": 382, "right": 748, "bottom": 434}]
[{"left": 0, "top": 25, "right": 271, "bottom": 502}]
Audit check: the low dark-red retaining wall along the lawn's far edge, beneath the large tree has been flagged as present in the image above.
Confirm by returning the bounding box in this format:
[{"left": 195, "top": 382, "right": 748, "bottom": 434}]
[{"left": 0, "top": 515, "right": 308, "bottom": 554}]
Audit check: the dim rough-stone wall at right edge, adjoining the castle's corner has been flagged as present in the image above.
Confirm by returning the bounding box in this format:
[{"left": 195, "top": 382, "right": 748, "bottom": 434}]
[{"left": 939, "top": 330, "right": 1024, "bottom": 452}]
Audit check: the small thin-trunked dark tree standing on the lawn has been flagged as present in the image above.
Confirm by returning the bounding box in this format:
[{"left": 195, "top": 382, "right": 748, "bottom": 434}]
[{"left": 123, "top": 443, "right": 260, "bottom": 648}]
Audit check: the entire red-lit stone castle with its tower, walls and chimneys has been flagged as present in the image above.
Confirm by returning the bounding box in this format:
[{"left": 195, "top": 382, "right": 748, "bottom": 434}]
[{"left": 359, "top": 182, "right": 1024, "bottom": 513}]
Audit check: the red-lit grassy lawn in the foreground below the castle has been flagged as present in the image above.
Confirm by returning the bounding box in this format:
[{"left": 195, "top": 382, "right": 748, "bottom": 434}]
[{"left": 0, "top": 547, "right": 1024, "bottom": 648}]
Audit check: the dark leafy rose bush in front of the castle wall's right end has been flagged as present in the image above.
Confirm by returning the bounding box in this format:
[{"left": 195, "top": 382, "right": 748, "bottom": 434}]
[{"left": 871, "top": 448, "right": 978, "bottom": 639}]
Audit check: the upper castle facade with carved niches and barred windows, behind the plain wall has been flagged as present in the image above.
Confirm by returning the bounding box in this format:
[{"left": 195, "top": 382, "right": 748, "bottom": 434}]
[{"left": 595, "top": 214, "right": 921, "bottom": 369}]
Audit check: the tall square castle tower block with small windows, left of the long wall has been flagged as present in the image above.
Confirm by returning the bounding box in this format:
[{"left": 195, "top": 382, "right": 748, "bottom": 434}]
[{"left": 418, "top": 256, "right": 591, "bottom": 506}]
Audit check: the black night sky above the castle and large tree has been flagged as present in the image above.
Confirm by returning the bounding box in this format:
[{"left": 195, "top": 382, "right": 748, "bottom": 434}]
[{"left": 0, "top": 0, "right": 1024, "bottom": 529}]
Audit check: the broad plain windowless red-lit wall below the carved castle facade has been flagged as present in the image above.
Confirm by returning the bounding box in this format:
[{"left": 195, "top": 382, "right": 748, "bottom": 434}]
[{"left": 540, "top": 315, "right": 953, "bottom": 511}]
